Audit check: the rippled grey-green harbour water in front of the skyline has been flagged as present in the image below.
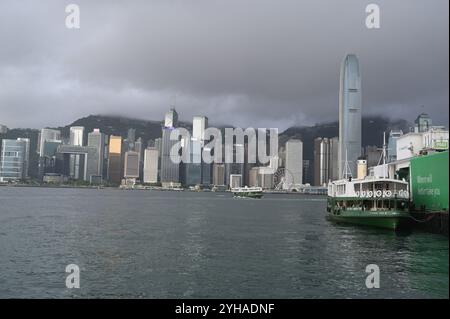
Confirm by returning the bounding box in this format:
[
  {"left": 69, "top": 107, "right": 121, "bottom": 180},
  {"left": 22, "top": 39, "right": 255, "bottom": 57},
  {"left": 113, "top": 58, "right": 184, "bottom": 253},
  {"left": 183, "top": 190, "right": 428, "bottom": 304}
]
[{"left": 0, "top": 187, "right": 449, "bottom": 298}]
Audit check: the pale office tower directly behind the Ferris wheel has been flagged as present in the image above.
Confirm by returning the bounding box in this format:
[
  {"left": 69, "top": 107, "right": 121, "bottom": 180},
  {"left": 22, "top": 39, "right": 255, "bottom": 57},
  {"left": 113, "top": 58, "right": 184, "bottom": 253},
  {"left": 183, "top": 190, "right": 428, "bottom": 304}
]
[{"left": 285, "top": 139, "right": 303, "bottom": 187}]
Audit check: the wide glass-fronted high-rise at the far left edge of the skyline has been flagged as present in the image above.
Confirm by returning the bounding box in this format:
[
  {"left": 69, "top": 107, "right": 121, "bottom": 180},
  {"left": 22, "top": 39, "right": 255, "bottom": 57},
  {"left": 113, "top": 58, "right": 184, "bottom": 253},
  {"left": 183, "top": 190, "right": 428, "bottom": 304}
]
[{"left": 0, "top": 139, "right": 29, "bottom": 182}]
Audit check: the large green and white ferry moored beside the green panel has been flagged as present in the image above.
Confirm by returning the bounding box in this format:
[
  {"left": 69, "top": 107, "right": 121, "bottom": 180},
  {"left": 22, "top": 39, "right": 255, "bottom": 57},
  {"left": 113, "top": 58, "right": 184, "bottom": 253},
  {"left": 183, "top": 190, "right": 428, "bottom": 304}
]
[{"left": 327, "top": 176, "right": 412, "bottom": 230}]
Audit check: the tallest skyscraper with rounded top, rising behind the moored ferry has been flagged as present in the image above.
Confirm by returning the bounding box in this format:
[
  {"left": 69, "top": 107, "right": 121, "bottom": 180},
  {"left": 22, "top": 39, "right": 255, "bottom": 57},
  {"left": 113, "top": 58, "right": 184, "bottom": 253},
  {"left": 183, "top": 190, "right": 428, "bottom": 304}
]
[{"left": 339, "top": 54, "right": 361, "bottom": 178}]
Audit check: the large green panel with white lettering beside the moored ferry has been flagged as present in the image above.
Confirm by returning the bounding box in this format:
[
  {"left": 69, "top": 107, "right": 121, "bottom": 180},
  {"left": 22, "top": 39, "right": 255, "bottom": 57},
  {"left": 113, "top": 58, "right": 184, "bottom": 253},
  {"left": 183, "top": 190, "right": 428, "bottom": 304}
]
[{"left": 411, "top": 151, "right": 449, "bottom": 211}]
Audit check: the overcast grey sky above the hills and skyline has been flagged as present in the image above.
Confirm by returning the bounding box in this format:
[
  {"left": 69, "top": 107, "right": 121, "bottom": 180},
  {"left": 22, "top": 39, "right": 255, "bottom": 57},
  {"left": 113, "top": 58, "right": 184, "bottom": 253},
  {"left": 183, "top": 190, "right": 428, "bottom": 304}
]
[{"left": 0, "top": 0, "right": 449, "bottom": 129}]
